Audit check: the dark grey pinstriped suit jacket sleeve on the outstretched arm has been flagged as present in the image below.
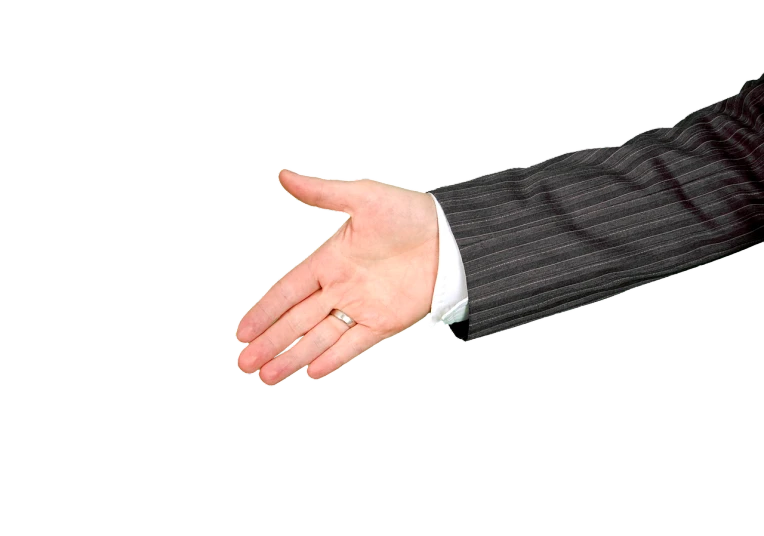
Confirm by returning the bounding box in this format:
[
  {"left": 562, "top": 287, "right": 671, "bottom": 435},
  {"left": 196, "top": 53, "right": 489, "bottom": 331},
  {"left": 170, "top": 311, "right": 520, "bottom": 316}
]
[{"left": 430, "top": 77, "right": 764, "bottom": 341}]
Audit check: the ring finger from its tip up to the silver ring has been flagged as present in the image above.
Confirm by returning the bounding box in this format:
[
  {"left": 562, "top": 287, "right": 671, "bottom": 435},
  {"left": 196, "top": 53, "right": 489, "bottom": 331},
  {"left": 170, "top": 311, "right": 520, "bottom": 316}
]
[{"left": 260, "top": 315, "right": 350, "bottom": 385}]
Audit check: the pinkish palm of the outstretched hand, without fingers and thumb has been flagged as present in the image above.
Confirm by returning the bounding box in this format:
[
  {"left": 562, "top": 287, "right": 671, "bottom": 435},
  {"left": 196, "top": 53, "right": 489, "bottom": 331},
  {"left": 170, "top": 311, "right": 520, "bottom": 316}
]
[{"left": 316, "top": 183, "right": 437, "bottom": 340}]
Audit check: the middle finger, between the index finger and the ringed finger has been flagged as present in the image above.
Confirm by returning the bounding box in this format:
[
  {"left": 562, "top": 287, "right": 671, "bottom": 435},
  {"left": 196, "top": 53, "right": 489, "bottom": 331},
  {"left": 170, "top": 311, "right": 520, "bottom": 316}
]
[{"left": 239, "top": 290, "right": 331, "bottom": 373}]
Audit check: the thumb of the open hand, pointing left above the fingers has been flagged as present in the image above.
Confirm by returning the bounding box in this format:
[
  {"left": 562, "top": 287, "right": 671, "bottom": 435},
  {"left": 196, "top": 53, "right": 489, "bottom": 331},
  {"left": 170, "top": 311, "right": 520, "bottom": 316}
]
[{"left": 278, "top": 169, "right": 359, "bottom": 213}]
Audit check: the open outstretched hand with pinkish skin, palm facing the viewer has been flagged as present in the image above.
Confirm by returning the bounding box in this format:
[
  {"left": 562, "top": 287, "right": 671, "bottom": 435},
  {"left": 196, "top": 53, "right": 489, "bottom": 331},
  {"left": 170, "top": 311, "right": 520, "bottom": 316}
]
[{"left": 236, "top": 170, "right": 438, "bottom": 385}]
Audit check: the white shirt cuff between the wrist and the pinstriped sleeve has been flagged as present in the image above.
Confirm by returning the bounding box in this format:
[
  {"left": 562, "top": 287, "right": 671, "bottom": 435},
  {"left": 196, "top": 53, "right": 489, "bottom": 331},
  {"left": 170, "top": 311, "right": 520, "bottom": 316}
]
[{"left": 430, "top": 194, "right": 469, "bottom": 324}]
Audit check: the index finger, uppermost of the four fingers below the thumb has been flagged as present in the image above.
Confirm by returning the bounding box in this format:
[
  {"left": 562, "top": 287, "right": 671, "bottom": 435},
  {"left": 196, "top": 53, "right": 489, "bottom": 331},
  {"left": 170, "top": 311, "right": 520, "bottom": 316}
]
[{"left": 236, "top": 252, "right": 321, "bottom": 342}]
